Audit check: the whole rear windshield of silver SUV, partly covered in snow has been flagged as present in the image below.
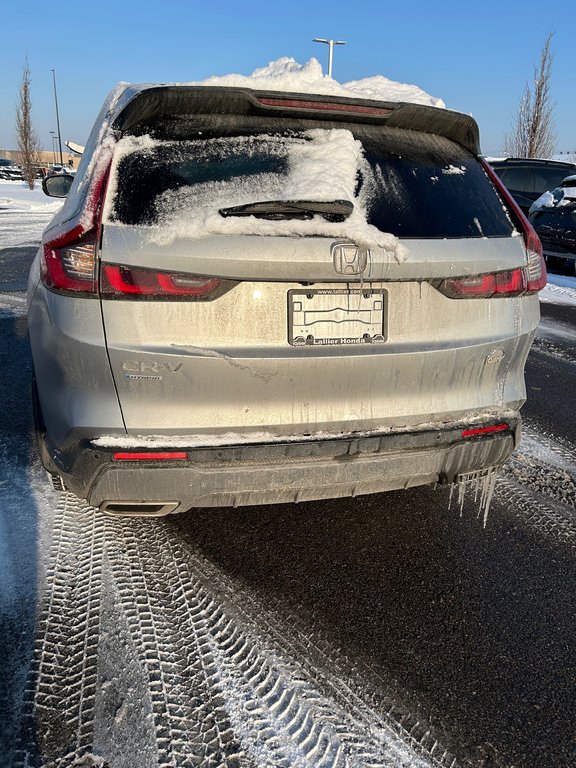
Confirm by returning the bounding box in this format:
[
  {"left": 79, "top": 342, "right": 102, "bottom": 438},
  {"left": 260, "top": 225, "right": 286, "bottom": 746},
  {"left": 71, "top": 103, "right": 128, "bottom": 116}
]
[{"left": 109, "top": 123, "right": 513, "bottom": 239}]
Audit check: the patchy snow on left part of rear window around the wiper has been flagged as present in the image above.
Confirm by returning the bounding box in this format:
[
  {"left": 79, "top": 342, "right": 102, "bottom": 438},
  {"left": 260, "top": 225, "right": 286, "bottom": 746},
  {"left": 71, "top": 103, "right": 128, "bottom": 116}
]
[{"left": 106, "top": 129, "right": 405, "bottom": 255}]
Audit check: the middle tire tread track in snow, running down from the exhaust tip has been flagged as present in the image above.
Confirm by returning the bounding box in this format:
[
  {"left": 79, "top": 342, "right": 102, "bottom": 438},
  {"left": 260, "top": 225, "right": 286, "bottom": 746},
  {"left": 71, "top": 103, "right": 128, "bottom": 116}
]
[{"left": 106, "top": 520, "right": 239, "bottom": 768}]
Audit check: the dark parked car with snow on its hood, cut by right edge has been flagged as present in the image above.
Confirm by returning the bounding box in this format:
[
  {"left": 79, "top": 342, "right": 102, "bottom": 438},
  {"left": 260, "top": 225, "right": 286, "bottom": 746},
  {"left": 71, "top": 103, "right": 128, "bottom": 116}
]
[{"left": 530, "top": 175, "right": 576, "bottom": 274}]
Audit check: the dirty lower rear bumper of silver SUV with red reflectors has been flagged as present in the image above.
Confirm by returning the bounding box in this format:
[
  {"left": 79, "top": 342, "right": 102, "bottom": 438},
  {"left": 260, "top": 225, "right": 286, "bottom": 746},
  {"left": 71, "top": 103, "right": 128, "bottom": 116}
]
[{"left": 40, "top": 414, "right": 520, "bottom": 515}]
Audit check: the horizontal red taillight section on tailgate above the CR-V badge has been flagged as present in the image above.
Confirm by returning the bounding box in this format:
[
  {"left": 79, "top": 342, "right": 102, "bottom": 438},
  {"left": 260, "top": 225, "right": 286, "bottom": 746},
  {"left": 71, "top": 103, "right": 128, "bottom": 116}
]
[{"left": 101, "top": 264, "right": 223, "bottom": 299}]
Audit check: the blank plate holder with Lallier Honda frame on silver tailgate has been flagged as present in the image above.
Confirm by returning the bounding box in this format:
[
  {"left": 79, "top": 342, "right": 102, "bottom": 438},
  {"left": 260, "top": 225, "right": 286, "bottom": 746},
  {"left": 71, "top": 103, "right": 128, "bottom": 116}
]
[{"left": 288, "top": 288, "right": 386, "bottom": 347}]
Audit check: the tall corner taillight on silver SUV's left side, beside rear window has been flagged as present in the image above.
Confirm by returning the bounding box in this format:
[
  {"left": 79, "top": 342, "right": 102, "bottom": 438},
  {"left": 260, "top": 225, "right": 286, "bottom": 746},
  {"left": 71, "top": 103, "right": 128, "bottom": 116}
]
[{"left": 40, "top": 154, "right": 110, "bottom": 296}]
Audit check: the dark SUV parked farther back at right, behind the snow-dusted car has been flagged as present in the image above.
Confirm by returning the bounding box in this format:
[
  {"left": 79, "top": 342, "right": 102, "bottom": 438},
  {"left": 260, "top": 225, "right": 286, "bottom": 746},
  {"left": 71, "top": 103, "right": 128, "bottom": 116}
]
[{"left": 489, "top": 157, "right": 576, "bottom": 215}]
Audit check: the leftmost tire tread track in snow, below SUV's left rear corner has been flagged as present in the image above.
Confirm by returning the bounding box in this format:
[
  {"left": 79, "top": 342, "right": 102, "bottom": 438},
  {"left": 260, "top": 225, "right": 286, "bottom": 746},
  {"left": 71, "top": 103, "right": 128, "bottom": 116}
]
[{"left": 13, "top": 494, "right": 103, "bottom": 768}]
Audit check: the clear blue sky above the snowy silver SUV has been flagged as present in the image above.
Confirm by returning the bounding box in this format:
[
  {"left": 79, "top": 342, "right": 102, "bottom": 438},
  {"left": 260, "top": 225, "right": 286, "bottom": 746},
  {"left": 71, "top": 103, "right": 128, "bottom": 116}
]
[{"left": 0, "top": 0, "right": 576, "bottom": 154}]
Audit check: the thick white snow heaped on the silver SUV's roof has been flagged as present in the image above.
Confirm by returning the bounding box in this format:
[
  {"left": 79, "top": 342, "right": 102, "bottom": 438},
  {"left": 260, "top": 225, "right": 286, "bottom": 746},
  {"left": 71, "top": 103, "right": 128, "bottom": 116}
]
[{"left": 185, "top": 56, "right": 445, "bottom": 108}]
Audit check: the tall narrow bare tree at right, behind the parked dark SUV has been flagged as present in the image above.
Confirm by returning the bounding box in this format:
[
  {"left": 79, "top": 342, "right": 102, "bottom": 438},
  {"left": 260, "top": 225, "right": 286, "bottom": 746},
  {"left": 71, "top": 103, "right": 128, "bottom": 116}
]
[{"left": 504, "top": 32, "right": 556, "bottom": 158}]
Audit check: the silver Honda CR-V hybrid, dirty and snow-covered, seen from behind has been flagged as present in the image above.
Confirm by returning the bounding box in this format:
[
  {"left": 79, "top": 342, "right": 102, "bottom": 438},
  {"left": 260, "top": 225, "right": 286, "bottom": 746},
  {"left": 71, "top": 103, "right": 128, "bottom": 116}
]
[{"left": 29, "top": 85, "right": 546, "bottom": 515}]
